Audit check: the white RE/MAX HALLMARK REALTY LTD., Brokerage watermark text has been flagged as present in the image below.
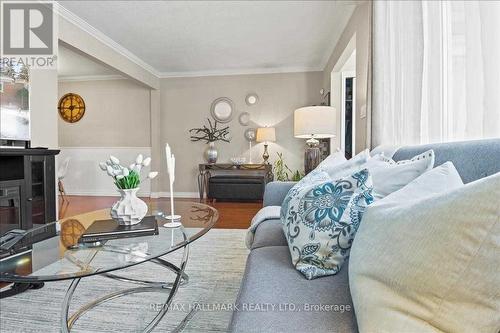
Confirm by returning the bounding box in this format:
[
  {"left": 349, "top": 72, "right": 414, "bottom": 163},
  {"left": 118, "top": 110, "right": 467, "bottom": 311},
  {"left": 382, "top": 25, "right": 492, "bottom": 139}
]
[{"left": 150, "top": 303, "right": 352, "bottom": 313}]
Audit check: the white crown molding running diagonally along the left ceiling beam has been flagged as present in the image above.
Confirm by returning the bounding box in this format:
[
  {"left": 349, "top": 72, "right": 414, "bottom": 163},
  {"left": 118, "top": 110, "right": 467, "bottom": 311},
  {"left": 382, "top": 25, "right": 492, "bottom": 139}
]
[{"left": 57, "top": 1, "right": 159, "bottom": 77}]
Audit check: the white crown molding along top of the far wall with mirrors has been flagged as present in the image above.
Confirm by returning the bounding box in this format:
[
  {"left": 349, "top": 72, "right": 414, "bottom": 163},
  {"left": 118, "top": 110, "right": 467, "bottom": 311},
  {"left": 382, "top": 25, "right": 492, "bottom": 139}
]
[{"left": 159, "top": 66, "right": 323, "bottom": 79}]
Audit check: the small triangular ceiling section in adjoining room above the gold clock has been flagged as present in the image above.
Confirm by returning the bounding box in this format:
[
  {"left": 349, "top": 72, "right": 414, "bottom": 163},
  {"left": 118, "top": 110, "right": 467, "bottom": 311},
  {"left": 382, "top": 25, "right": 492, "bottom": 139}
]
[{"left": 57, "top": 44, "right": 122, "bottom": 80}]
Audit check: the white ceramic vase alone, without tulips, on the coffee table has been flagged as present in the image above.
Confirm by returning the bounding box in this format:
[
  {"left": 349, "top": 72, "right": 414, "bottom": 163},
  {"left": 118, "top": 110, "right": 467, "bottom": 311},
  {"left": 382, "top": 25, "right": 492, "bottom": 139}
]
[{"left": 111, "top": 188, "right": 148, "bottom": 225}]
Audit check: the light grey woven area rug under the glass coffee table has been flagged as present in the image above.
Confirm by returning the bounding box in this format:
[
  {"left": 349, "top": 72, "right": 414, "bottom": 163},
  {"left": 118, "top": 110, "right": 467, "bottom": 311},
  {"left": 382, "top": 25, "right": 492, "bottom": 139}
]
[{"left": 0, "top": 229, "right": 248, "bottom": 333}]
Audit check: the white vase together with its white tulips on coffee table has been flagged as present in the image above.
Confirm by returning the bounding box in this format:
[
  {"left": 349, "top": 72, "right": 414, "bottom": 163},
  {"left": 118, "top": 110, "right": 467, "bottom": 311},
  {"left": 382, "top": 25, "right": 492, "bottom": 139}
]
[{"left": 99, "top": 154, "right": 158, "bottom": 225}]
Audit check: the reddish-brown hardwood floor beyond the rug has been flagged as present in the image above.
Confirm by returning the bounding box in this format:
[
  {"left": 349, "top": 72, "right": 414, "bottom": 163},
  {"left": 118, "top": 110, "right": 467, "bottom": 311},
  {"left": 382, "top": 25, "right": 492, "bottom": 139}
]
[{"left": 59, "top": 195, "right": 262, "bottom": 229}]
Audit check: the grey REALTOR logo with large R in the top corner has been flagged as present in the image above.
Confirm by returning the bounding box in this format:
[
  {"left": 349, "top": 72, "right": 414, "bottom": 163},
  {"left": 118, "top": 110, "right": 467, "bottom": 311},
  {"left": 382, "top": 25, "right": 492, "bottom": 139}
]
[{"left": 0, "top": 1, "right": 57, "bottom": 68}]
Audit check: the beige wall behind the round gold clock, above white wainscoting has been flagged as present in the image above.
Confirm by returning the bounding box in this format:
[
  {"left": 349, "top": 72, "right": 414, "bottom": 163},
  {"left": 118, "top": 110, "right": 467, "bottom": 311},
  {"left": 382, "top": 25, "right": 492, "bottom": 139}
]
[{"left": 58, "top": 80, "right": 151, "bottom": 147}]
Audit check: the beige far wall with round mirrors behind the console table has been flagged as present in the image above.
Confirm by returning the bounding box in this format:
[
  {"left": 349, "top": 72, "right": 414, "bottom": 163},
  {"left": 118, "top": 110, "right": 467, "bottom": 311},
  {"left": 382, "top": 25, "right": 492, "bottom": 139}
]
[{"left": 162, "top": 72, "right": 323, "bottom": 192}]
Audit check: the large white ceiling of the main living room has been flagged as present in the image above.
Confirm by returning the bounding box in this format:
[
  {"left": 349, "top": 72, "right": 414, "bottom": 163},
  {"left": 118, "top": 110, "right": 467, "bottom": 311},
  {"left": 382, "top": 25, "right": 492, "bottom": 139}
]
[{"left": 60, "top": 1, "right": 356, "bottom": 77}]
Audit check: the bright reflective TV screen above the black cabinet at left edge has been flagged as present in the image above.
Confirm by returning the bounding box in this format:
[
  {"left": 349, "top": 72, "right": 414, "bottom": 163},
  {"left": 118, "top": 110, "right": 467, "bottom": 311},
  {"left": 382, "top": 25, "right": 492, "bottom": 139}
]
[{"left": 0, "top": 64, "right": 31, "bottom": 141}]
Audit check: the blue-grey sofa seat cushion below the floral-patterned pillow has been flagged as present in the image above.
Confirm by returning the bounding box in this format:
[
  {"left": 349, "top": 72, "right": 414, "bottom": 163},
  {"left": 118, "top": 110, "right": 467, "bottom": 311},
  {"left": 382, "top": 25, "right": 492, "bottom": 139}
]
[{"left": 229, "top": 246, "right": 357, "bottom": 333}]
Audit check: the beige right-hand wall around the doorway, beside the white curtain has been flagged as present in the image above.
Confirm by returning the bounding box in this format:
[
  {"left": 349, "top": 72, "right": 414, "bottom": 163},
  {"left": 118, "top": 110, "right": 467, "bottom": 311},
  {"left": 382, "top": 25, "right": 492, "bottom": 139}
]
[{"left": 323, "top": 1, "right": 371, "bottom": 152}]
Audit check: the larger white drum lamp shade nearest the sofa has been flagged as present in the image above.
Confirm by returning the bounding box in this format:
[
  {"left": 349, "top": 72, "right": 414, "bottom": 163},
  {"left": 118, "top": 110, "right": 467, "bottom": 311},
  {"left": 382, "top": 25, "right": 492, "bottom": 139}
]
[{"left": 292, "top": 106, "right": 337, "bottom": 139}]
